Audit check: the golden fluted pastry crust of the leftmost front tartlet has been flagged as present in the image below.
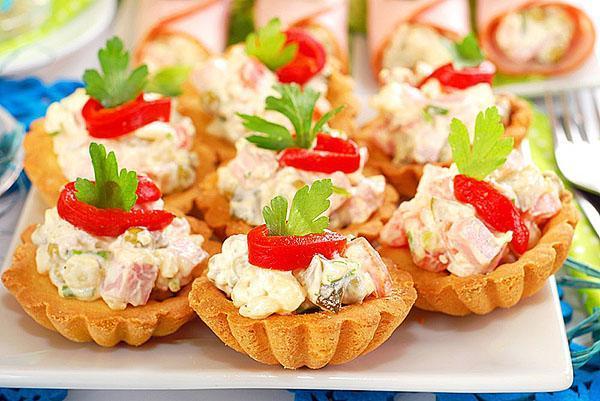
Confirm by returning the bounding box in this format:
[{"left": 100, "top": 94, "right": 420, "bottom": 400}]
[{"left": 2, "top": 220, "right": 220, "bottom": 347}]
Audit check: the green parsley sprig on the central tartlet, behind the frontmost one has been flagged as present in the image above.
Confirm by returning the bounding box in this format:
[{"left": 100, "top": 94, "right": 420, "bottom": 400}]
[{"left": 238, "top": 84, "right": 343, "bottom": 151}]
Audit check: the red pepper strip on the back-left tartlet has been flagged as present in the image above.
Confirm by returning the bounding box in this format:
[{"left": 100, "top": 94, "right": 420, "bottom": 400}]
[{"left": 81, "top": 95, "right": 171, "bottom": 138}]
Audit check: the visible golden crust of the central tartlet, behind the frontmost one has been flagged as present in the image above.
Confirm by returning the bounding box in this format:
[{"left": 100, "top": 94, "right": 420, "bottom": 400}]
[{"left": 195, "top": 172, "right": 398, "bottom": 240}]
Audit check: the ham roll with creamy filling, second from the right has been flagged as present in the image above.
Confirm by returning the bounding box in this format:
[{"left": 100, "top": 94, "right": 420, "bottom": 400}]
[{"left": 367, "top": 0, "right": 470, "bottom": 79}]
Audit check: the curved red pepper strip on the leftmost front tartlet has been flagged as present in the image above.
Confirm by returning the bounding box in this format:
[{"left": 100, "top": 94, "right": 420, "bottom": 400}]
[{"left": 56, "top": 182, "right": 175, "bottom": 237}]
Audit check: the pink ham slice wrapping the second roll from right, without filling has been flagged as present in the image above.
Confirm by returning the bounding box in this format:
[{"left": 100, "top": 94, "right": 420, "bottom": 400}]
[{"left": 367, "top": 0, "right": 471, "bottom": 76}]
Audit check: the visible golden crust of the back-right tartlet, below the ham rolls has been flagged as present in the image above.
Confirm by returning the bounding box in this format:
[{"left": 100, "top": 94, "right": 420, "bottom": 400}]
[{"left": 356, "top": 95, "right": 533, "bottom": 198}]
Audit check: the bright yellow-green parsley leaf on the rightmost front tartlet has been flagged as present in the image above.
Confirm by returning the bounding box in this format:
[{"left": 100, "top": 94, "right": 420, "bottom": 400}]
[{"left": 448, "top": 107, "right": 514, "bottom": 180}]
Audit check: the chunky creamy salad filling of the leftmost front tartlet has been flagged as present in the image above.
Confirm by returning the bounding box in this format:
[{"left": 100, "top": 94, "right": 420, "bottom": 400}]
[{"left": 31, "top": 201, "right": 208, "bottom": 310}]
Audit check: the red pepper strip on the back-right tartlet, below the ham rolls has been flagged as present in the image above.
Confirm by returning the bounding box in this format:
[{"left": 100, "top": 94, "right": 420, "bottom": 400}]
[{"left": 419, "top": 61, "right": 496, "bottom": 89}]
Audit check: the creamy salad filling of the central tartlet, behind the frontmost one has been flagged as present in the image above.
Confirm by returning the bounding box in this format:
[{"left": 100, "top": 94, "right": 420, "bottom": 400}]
[{"left": 217, "top": 139, "right": 385, "bottom": 228}]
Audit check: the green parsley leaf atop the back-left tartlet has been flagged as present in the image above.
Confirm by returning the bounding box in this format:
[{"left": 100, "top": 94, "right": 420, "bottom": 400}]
[{"left": 83, "top": 36, "right": 148, "bottom": 107}]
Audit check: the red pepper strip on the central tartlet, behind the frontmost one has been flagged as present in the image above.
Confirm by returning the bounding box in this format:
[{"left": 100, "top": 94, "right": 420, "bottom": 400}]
[{"left": 279, "top": 134, "right": 360, "bottom": 174}]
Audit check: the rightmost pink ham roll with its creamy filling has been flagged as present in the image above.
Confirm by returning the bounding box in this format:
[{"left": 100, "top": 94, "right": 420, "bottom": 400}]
[{"left": 477, "top": 0, "right": 596, "bottom": 75}]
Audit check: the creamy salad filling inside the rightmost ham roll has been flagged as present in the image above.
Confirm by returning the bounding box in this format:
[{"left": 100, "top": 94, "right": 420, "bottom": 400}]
[{"left": 496, "top": 5, "right": 575, "bottom": 64}]
